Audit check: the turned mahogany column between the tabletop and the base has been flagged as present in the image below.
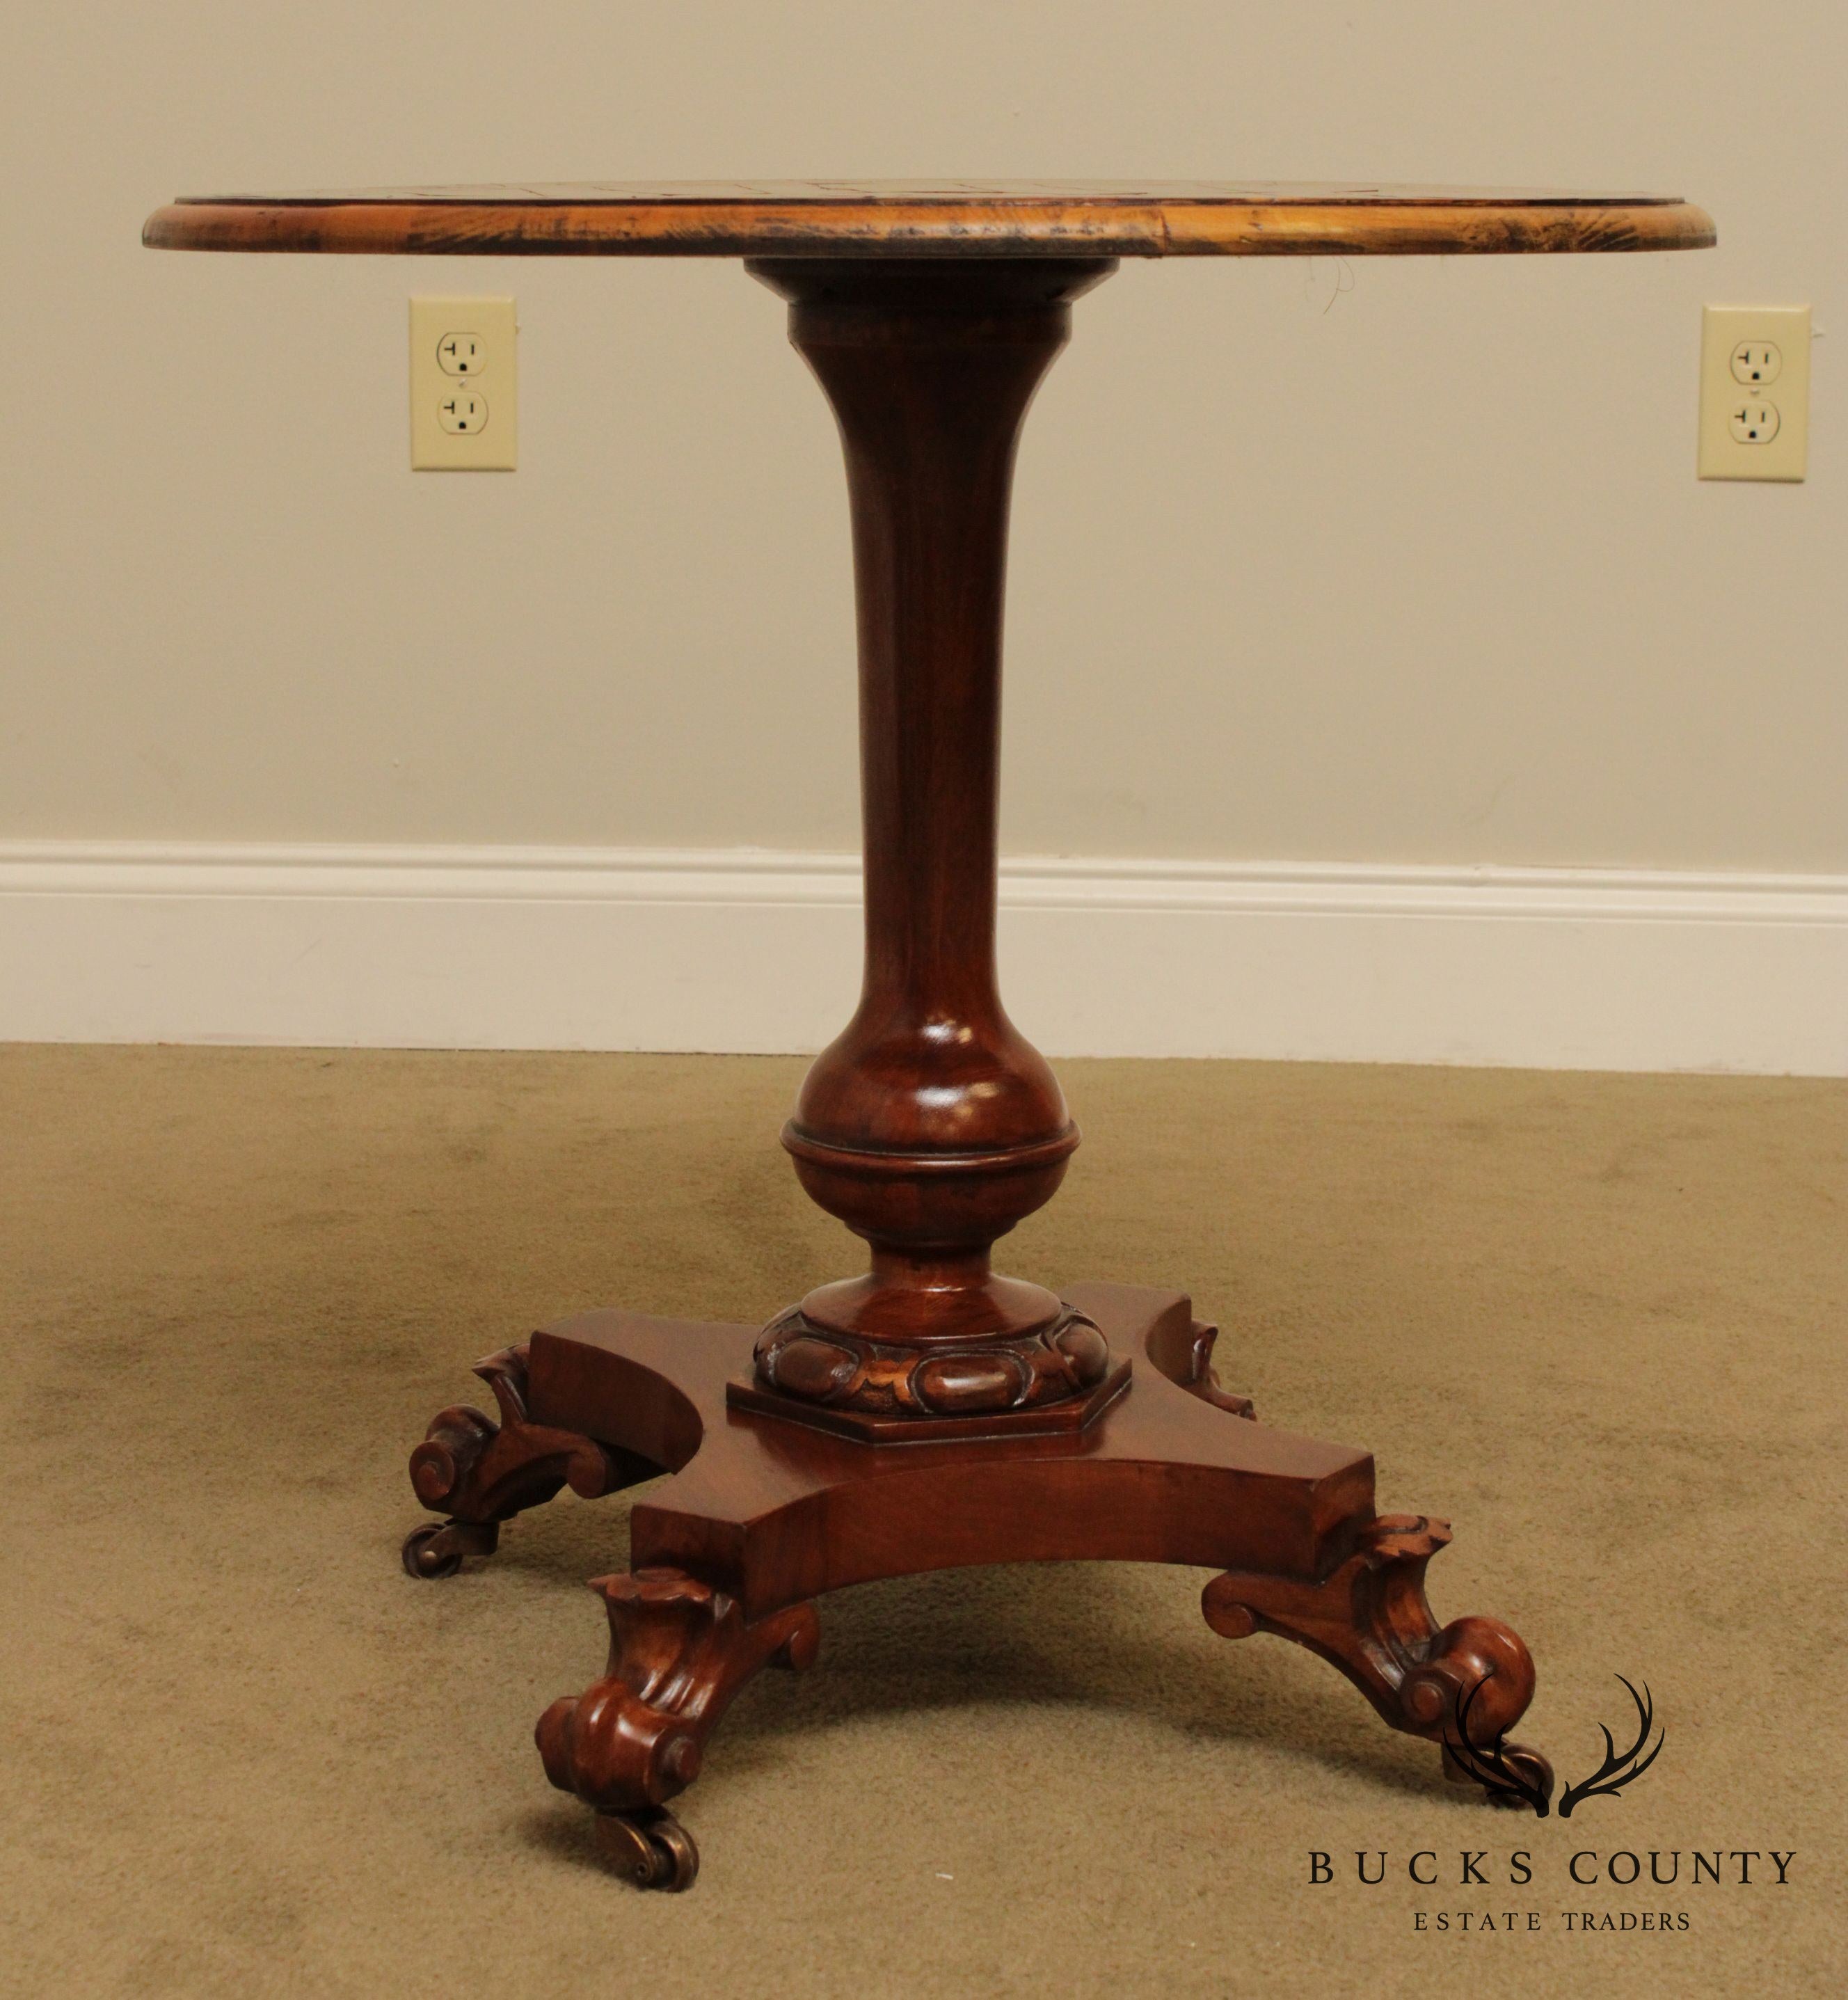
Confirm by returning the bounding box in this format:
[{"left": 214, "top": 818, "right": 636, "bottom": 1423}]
[{"left": 748, "top": 258, "right": 1114, "bottom": 1430}]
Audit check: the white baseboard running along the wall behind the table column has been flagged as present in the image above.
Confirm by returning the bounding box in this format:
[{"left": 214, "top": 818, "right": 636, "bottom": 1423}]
[{"left": 0, "top": 842, "right": 1848, "bottom": 1076}]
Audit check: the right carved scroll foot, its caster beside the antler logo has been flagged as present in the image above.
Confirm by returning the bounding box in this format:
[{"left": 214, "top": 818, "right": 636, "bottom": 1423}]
[{"left": 1200, "top": 1514, "right": 1552, "bottom": 1812}]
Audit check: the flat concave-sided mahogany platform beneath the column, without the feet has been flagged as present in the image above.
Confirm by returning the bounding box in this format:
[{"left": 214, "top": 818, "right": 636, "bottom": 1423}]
[{"left": 532, "top": 1284, "right": 1374, "bottom": 1618}]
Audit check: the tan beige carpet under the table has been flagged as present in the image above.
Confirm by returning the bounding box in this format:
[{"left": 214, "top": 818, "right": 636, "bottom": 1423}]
[{"left": 0, "top": 1048, "right": 1848, "bottom": 2000}]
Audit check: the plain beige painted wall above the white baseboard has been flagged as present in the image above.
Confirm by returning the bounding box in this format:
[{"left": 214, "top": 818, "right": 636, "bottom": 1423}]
[{"left": 0, "top": 0, "right": 1848, "bottom": 870}]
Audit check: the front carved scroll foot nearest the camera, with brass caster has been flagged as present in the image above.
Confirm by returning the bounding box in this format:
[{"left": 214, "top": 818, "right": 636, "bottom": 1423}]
[{"left": 534, "top": 1570, "right": 818, "bottom": 1888}]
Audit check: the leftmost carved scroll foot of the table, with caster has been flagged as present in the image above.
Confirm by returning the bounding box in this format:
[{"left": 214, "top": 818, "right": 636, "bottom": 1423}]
[{"left": 404, "top": 1348, "right": 632, "bottom": 1578}]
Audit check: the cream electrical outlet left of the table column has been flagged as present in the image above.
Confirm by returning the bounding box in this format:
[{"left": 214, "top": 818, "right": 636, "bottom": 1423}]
[{"left": 410, "top": 298, "right": 520, "bottom": 472}]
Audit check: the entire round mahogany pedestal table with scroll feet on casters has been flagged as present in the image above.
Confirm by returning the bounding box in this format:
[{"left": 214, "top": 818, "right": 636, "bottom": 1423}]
[{"left": 144, "top": 182, "right": 1714, "bottom": 1888}]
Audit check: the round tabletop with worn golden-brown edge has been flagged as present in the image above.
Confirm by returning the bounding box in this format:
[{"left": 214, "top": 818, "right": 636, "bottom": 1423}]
[{"left": 144, "top": 180, "right": 1714, "bottom": 256}]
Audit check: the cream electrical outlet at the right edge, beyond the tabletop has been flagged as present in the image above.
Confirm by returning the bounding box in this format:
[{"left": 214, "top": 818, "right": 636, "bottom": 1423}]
[{"left": 1698, "top": 306, "right": 1810, "bottom": 480}]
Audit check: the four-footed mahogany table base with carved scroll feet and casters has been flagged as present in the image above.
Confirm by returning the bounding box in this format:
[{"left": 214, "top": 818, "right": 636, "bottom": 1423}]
[{"left": 406, "top": 1284, "right": 1552, "bottom": 1888}]
